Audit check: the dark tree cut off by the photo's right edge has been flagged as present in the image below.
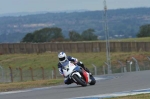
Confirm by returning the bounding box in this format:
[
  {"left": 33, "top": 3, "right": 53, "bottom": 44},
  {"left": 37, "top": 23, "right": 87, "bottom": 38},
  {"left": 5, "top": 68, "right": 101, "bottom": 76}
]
[{"left": 137, "top": 24, "right": 150, "bottom": 37}]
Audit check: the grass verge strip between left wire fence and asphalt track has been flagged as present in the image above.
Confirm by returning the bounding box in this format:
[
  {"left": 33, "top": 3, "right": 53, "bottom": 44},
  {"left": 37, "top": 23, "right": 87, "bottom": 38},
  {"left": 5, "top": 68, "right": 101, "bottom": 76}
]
[{"left": 0, "top": 79, "right": 63, "bottom": 92}]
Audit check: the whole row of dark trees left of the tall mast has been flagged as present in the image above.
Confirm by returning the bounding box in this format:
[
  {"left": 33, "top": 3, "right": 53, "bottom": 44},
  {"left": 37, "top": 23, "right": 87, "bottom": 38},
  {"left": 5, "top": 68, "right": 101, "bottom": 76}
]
[{"left": 21, "top": 27, "right": 97, "bottom": 43}]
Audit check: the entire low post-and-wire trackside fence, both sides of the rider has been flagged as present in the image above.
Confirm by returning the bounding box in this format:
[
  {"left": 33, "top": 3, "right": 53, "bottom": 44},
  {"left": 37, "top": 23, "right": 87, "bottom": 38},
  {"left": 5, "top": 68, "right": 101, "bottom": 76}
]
[{"left": 0, "top": 57, "right": 150, "bottom": 83}]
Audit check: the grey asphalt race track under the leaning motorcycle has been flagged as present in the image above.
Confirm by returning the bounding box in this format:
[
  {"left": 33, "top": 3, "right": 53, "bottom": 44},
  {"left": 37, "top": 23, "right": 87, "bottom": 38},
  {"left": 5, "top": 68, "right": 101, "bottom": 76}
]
[{"left": 0, "top": 70, "right": 150, "bottom": 99}]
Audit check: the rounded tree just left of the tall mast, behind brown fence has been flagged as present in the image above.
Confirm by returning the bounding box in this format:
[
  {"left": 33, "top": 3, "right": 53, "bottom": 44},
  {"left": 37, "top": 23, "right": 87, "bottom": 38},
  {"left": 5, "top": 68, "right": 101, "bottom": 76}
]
[{"left": 81, "top": 29, "right": 97, "bottom": 40}]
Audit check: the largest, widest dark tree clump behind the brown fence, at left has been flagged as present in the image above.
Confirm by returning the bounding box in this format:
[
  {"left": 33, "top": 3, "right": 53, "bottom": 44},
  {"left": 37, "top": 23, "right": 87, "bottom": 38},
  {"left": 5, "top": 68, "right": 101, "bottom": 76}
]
[{"left": 22, "top": 27, "right": 64, "bottom": 42}]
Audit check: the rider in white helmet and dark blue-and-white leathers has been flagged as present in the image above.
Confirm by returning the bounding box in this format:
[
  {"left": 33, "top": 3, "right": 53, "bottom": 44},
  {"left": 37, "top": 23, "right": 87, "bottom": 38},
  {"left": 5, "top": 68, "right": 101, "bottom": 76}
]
[{"left": 58, "top": 52, "right": 91, "bottom": 84}]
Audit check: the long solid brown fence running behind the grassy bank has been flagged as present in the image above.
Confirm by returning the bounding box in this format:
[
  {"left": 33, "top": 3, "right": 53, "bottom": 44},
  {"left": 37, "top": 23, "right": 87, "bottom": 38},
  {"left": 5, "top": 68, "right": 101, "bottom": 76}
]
[{"left": 0, "top": 42, "right": 150, "bottom": 54}]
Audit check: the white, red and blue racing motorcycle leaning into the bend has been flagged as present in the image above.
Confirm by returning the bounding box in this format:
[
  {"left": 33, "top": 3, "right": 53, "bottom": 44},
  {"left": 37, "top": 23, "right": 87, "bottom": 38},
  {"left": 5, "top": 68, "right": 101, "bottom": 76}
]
[{"left": 62, "top": 60, "right": 96, "bottom": 86}]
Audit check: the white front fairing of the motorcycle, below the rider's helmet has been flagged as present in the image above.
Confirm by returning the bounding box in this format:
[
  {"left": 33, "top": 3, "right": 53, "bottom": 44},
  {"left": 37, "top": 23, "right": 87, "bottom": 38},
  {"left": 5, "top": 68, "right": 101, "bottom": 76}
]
[{"left": 62, "top": 61, "right": 76, "bottom": 76}]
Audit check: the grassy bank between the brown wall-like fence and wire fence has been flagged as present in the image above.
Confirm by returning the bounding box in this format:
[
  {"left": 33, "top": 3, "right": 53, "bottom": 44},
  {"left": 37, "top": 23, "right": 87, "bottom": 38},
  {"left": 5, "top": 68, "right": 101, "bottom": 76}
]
[{"left": 0, "top": 52, "right": 150, "bottom": 69}]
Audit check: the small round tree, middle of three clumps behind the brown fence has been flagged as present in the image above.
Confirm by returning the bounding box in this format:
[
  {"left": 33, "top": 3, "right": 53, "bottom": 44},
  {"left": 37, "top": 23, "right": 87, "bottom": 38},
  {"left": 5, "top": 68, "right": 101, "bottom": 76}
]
[{"left": 69, "top": 31, "right": 81, "bottom": 41}]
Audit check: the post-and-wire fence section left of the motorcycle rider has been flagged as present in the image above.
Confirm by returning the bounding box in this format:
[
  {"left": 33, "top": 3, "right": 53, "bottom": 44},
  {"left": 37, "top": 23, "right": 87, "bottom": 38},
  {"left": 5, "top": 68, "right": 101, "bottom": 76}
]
[{"left": 0, "top": 66, "right": 61, "bottom": 82}]
